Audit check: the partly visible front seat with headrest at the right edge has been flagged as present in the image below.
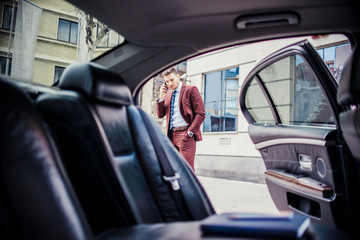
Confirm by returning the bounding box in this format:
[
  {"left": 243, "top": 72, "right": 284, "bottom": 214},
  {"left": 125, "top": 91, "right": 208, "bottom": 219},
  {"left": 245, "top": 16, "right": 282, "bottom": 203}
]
[{"left": 337, "top": 47, "right": 360, "bottom": 160}]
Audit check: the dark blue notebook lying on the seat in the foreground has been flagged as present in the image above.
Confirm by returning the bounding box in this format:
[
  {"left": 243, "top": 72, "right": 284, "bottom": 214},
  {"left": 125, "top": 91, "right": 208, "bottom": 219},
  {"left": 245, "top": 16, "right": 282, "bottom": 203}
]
[{"left": 201, "top": 212, "right": 310, "bottom": 239}]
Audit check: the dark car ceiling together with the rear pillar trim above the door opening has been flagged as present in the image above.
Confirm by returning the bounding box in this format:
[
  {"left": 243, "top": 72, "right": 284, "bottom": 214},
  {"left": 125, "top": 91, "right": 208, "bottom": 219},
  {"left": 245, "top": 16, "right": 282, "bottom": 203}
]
[{"left": 65, "top": 0, "right": 360, "bottom": 93}]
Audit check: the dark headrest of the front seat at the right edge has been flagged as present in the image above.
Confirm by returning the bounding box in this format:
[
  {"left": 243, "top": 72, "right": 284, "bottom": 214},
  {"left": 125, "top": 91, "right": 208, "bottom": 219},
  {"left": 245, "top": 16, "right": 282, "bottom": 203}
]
[{"left": 337, "top": 47, "right": 360, "bottom": 105}]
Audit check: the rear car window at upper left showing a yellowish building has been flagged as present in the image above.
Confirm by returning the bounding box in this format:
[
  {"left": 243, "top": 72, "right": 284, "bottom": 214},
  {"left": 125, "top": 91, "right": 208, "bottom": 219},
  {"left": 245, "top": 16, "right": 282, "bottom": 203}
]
[{"left": 0, "top": 0, "right": 125, "bottom": 86}]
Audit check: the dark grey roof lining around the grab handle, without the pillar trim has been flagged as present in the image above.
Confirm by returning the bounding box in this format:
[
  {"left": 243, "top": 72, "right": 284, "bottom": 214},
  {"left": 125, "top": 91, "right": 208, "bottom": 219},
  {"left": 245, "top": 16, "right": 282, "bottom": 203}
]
[{"left": 67, "top": 0, "right": 359, "bottom": 47}]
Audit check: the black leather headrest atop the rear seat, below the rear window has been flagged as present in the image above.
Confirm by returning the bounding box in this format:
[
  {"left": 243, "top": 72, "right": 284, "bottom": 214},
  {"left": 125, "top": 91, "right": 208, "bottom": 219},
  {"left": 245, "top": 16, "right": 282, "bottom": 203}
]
[{"left": 59, "top": 62, "right": 133, "bottom": 105}]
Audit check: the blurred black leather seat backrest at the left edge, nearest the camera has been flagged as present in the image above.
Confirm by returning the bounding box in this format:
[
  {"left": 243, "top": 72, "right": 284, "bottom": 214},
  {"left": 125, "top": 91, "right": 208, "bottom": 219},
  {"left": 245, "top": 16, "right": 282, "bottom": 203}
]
[{"left": 0, "top": 78, "right": 92, "bottom": 239}]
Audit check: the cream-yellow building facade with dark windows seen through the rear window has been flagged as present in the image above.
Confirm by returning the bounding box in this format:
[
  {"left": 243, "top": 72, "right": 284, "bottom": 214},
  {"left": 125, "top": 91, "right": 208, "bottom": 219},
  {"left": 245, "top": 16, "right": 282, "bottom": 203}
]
[{"left": 0, "top": 0, "right": 124, "bottom": 86}]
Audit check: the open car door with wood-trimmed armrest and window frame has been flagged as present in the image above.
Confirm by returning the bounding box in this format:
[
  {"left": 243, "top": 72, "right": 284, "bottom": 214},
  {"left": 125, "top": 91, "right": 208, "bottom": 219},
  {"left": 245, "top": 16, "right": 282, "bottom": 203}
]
[{"left": 240, "top": 40, "right": 349, "bottom": 232}]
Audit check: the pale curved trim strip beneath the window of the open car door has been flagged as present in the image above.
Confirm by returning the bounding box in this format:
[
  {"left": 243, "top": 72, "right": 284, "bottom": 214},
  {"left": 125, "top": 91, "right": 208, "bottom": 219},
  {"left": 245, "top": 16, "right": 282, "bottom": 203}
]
[{"left": 255, "top": 138, "right": 335, "bottom": 150}]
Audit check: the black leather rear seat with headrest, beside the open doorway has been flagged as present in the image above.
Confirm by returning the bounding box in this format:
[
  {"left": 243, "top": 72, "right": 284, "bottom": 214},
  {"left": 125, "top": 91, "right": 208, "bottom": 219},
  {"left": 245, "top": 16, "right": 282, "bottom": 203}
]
[{"left": 37, "top": 63, "right": 214, "bottom": 233}]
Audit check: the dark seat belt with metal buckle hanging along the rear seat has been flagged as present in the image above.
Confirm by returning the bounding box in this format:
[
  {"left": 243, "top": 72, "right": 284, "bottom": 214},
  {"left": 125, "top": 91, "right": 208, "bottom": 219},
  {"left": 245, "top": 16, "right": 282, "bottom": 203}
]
[{"left": 138, "top": 108, "right": 193, "bottom": 219}]
